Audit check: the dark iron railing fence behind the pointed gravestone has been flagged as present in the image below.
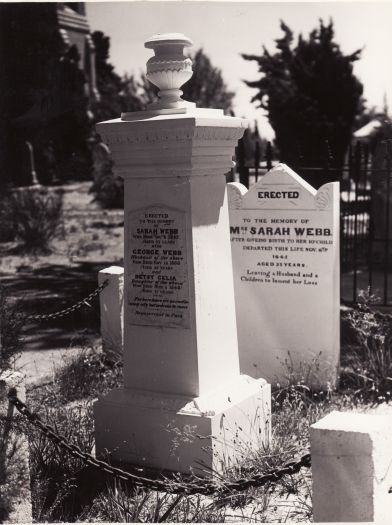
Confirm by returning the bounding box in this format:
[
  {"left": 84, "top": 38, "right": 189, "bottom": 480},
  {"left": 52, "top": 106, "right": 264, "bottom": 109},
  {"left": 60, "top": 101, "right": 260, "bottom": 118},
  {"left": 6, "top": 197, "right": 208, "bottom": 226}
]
[{"left": 236, "top": 140, "right": 392, "bottom": 306}]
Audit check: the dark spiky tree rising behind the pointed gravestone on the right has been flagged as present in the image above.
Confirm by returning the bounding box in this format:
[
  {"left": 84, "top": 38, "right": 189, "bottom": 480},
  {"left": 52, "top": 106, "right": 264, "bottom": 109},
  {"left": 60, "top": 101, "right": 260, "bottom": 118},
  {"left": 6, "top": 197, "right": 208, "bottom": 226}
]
[{"left": 242, "top": 20, "right": 363, "bottom": 186}]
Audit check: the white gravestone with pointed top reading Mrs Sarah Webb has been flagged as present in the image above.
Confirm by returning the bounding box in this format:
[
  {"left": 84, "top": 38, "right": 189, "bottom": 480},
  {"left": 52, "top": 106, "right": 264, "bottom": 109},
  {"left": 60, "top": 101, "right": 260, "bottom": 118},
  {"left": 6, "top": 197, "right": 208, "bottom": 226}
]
[{"left": 228, "top": 164, "right": 340, "bottom": 387}]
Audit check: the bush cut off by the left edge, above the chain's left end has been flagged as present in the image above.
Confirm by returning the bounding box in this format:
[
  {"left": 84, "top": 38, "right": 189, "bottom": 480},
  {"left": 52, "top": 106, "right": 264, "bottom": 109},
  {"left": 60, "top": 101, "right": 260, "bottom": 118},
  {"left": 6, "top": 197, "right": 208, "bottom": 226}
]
[{"left": 0, "top": 285, "right": 24, "bottom": 370}]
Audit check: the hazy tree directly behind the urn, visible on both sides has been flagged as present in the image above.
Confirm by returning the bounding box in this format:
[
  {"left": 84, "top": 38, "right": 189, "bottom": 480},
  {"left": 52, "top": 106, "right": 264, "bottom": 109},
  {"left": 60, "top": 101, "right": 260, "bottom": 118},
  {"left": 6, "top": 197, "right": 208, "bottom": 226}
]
[{"left": 142, "top": 49, "right": 234, "bottom": 113}]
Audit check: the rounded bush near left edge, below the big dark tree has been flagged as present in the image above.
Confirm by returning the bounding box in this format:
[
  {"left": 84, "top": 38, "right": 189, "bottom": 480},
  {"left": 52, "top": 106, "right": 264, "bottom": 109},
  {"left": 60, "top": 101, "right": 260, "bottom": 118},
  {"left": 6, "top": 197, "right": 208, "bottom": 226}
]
[{"left": 2, "top": 187, "right": 63, "bottom": 253}]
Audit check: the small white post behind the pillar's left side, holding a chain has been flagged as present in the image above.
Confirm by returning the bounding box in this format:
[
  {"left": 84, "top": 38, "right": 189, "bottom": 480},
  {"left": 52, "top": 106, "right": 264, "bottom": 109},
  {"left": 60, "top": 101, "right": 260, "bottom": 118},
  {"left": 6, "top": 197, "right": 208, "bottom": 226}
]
[{"left": 98, "top": 266, "right": 124, "bottom": 357}]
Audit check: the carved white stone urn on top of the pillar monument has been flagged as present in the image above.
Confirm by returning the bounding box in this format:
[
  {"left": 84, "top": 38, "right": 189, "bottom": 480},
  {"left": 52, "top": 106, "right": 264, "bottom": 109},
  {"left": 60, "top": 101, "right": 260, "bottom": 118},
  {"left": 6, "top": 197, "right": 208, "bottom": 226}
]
[{"left": 144, "top": 33, "right": 195, "bottom": 109}]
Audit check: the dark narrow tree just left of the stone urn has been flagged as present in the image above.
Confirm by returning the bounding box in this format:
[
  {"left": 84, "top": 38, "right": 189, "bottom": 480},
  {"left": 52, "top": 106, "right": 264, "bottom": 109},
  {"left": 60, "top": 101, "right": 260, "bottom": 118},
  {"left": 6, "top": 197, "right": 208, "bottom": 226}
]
[{"left": 92, "top": 31, "right": 144, "bottom": 122}]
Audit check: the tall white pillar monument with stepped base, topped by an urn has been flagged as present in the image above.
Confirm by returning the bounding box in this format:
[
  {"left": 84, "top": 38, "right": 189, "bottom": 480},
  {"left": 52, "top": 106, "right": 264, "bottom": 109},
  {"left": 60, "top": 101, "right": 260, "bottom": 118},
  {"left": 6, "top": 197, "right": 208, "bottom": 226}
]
[{"left": 95, "top": 34, "right": 270, "bottom": 474}]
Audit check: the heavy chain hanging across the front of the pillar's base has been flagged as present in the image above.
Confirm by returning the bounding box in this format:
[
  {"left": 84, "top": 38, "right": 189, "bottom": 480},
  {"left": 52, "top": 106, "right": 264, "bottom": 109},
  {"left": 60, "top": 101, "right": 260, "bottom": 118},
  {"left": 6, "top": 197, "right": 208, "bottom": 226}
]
[{"left": 8, "top": 389, "right": 311, "bottom": 496}]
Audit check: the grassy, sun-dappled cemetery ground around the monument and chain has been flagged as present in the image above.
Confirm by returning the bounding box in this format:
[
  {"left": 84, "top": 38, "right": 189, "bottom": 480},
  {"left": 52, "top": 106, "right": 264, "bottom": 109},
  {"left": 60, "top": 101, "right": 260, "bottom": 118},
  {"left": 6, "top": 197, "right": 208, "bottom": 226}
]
[{"left": 0, "top": 183, "right": 392, "bottom": 522}]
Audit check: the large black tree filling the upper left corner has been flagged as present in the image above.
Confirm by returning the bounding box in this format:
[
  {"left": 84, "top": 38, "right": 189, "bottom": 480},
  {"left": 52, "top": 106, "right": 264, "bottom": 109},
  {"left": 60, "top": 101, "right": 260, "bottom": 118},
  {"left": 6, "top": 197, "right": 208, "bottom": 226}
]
[{"left": 0, "top": 3, "right": 91, "bottom": 184}]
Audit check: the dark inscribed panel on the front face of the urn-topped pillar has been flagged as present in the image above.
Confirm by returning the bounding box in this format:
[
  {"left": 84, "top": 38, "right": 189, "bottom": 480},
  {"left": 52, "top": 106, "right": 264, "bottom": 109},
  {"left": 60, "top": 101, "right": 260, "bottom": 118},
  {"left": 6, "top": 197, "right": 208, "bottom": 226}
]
[{"left": 128, "top": 206, "right": 189, "bottom": 328}]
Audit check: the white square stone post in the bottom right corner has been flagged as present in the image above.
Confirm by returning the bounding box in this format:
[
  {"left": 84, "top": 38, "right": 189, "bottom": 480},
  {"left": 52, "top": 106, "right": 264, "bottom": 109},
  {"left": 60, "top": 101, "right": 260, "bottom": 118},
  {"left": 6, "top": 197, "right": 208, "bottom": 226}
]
[{"left": 310, "top": 411, "right": 392, "bottom": 523}]
